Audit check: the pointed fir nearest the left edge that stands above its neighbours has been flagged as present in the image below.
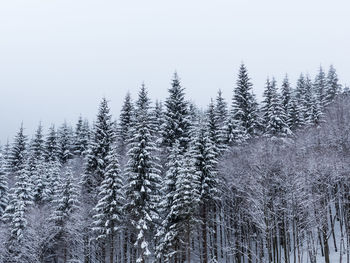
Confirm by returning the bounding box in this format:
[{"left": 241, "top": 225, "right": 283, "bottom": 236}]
[{"left": 8, "top": 123, "right": 27, "bottom": 173}]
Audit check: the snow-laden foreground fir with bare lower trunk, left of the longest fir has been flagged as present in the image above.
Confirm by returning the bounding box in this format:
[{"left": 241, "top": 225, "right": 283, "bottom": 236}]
[{"left": 93, "top": 149, "right": 125, "bottom": 263}]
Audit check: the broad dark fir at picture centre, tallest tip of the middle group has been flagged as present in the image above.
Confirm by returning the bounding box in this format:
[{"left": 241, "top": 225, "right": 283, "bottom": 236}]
[{"left": 163, "top": 72, "right": 191, "bottom": 153}]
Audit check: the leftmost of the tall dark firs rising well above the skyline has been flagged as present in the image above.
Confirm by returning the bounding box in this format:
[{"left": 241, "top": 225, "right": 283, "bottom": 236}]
[{"left": 83, "top": 98, "right": 115, "bottom": 195}]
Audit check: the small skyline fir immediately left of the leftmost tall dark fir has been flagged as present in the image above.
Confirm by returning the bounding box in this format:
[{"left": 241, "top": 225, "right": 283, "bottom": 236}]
[{"left": 74, "top": 116, "right": 90, "bottom": 156}]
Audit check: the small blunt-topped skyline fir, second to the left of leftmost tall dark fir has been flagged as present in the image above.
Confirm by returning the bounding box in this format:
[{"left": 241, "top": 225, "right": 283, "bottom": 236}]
[{"left": 58, "top": 122, "right": 73, "bottom": 164}]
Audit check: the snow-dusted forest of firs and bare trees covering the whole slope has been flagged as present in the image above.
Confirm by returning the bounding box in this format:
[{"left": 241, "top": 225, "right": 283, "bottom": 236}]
[{"left": 0, "top": 64, "right": 350, "bottom": 263}]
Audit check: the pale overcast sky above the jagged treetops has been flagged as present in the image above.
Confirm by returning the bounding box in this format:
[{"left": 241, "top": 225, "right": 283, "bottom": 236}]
[{"left": 0, "top": 0, "right": 350, "bottom": 143}]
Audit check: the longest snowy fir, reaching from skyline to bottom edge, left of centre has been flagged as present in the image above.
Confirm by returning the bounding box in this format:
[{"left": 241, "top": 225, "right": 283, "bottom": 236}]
[{"left": 125, "top": 85, "right": 160, "bottom": 263}]
